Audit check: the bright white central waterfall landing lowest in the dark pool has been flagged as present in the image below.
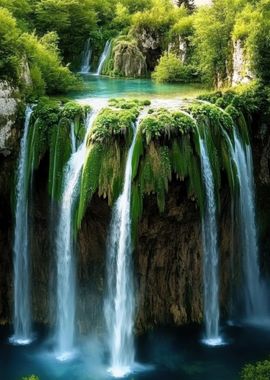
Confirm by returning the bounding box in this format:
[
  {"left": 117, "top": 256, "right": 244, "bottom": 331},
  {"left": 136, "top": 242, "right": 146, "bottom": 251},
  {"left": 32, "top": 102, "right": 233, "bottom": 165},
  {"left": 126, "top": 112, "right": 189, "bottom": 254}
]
[{"left": 105, "top": 124, "right": 136, "bottom": 377}]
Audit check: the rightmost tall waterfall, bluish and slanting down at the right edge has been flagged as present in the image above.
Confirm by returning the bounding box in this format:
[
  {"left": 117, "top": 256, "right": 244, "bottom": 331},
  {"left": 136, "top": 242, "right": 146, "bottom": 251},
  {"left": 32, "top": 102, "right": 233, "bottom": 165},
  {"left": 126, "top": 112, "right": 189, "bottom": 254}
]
[{"left": 234, "top": 132, "right": 269, "bottom": 324}]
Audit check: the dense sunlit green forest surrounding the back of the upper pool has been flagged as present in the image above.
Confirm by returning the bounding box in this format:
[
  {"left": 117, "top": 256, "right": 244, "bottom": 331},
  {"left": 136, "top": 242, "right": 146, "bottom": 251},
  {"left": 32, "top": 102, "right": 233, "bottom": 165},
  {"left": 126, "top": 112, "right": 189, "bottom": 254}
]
[{"left": 0, "top": 0, "right": 270, "bottom": 95}]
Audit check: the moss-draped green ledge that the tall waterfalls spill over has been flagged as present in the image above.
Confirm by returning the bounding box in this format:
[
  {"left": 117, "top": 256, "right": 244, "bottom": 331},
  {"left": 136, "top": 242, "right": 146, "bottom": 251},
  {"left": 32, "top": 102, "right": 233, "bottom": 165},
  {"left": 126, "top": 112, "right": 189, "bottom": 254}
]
[{"left": 21, "top": 86, "right": 262, "bottom": 240}]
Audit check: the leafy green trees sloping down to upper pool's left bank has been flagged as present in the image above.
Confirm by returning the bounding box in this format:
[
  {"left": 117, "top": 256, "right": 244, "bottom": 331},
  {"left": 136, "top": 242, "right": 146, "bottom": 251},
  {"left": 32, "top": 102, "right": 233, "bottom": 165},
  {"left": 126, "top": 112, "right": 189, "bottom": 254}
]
[{"left": 0, "top": 8, "right": 76, "bottom": 95}]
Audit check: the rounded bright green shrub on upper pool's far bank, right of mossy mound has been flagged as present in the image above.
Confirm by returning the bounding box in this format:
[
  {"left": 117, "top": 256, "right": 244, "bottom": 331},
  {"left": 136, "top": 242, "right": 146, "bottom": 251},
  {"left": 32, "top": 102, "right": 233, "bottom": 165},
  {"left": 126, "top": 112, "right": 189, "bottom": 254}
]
[{"left": 152, "top": 53, "right": 194, "bottom": 83}]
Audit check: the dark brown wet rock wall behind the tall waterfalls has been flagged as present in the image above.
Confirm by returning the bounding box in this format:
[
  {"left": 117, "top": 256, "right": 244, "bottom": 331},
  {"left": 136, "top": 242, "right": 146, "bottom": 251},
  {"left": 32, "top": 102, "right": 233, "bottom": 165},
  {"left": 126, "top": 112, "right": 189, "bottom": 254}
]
[{"left": 0, "top": 105, "right": 270, "bottom": 333}]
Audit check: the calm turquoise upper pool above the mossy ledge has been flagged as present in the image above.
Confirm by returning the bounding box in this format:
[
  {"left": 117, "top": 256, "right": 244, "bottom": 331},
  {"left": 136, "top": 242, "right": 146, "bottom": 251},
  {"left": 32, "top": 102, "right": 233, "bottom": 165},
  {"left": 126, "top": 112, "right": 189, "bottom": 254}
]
[{"left": 70, "top": 75, "right": 206, "bottom": 99}]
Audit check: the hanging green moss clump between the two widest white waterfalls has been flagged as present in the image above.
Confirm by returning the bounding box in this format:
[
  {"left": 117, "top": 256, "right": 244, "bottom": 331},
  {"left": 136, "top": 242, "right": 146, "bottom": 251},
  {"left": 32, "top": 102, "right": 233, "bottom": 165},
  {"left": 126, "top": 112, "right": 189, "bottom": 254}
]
[{"left": 77, "top": 107, "right": 139, "bottom": 228}]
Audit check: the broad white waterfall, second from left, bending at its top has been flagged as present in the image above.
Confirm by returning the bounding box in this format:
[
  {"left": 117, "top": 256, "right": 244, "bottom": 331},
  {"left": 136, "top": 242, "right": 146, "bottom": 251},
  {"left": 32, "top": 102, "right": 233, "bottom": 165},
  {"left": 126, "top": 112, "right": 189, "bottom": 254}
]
[{"left": 56, "top": 111, "right": 96, "bottom": 360}]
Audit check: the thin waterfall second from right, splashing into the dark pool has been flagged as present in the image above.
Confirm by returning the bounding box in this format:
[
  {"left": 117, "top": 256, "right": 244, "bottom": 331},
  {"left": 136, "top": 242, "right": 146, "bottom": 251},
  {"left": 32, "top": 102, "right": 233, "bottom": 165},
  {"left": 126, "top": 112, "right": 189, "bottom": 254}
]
[{"left": 200, "top": 138, "right": 222, "bottom": 346}]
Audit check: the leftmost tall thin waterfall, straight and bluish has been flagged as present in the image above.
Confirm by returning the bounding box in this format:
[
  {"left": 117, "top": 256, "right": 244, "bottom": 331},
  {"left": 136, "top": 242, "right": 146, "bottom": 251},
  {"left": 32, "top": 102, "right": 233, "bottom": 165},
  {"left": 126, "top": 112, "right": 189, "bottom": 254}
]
[{"left": 10, "top": 107, "right": 33, "bottom": 345}]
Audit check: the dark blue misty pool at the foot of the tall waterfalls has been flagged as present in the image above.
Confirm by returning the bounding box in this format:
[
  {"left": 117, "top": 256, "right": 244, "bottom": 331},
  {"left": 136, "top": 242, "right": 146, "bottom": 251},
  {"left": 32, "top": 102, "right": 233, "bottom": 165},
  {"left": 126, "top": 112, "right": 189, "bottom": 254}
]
[{"left": 0, "top": 327, "right": 270, "bottom": 380}]
